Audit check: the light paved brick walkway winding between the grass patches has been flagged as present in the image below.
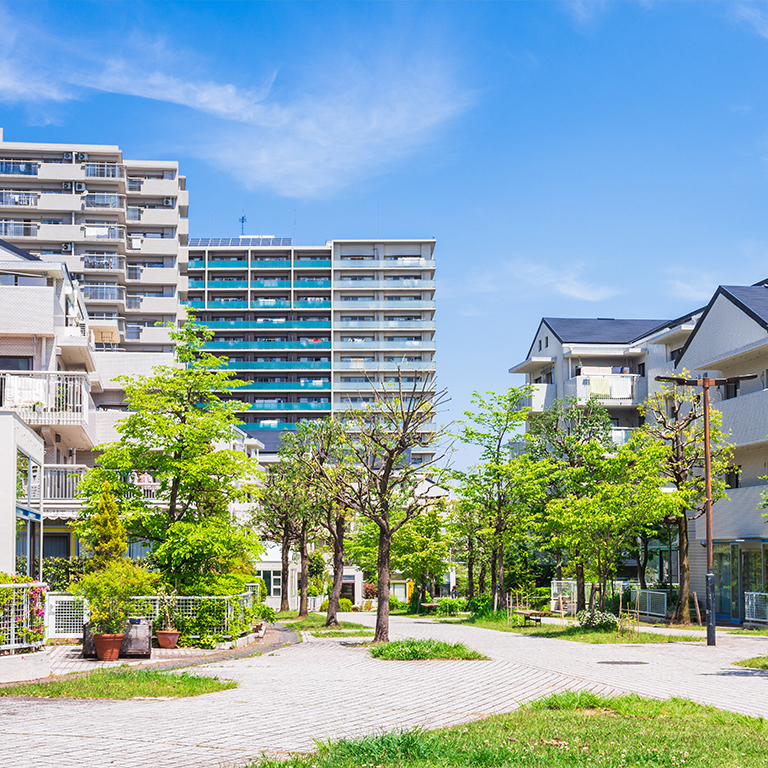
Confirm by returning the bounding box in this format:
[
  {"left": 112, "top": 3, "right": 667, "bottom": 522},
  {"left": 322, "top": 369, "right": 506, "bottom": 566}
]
[{"left": 0, "top": 614, "right": 768, "bottom": 768}]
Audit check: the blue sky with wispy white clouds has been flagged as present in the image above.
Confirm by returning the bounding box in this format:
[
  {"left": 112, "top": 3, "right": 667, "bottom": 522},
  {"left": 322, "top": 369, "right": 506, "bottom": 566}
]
[{"left": 0, "top": 0, "right": 768, "bottom": 462}]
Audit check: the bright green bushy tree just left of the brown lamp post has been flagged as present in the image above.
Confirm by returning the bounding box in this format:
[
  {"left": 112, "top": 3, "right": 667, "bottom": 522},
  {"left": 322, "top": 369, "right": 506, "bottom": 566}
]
[{"left": 547, "top": 439, "right": 680, "bottom": 611}]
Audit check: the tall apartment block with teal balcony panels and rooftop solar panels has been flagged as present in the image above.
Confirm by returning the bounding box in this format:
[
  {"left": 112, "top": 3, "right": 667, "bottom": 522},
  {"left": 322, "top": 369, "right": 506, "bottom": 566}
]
[{"left": 181, "top": 237, "right": 435, "bottom": 462}]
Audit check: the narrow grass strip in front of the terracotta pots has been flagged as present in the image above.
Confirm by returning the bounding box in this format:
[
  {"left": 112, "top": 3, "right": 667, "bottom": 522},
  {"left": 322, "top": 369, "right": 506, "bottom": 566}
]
[{"left": 0, "top": 668, "right": 237, "bottom": 699}]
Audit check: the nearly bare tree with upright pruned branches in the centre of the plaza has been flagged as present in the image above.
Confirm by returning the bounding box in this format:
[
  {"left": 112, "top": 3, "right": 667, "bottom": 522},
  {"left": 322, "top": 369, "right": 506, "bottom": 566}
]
[{"left": 315, "top": 372, "right": 447, "bottom": 642}]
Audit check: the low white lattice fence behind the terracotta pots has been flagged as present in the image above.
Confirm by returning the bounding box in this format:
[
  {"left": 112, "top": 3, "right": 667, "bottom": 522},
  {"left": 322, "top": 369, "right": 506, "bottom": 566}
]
[{"left": 45, "top": 584, "right": 259, "bottom": 638}]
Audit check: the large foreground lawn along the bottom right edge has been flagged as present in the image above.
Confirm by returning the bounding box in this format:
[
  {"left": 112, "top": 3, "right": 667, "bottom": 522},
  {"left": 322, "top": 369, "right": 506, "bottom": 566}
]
[{"left": 254, "top": 693, "right": 768, "bottom": 768}]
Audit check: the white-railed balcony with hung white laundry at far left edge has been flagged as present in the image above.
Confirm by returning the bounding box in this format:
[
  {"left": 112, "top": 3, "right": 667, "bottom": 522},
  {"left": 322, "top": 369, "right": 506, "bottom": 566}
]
[{"left": 0, "top": 371, "right": 94, "bottom": 448}]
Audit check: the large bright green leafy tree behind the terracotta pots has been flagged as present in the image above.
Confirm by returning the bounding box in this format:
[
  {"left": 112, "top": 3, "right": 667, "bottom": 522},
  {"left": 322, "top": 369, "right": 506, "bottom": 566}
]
[{"left": 78, "top": 316, "right": 259, "bottom": 584}]
